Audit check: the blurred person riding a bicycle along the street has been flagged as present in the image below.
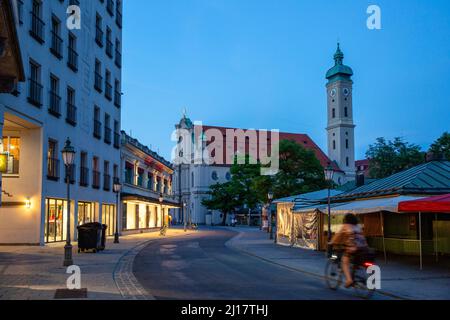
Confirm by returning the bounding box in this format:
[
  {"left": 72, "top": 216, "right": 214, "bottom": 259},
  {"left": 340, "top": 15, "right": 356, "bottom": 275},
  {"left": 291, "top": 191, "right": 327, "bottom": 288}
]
[{"left": 330, "top": 213, "right": 368, "bottom": 288}]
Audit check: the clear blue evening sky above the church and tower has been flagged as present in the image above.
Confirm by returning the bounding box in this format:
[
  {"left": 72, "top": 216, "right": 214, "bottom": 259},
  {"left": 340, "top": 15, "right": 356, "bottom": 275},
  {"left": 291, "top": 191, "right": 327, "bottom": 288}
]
[{"left": 122, "top": 0, "right": 450, "bottom": 158}]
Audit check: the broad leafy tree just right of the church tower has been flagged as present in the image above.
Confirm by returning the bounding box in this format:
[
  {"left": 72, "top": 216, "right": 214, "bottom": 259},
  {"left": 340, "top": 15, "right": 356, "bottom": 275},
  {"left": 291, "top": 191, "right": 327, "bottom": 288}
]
[{"left": 366, "top": 138, "right": 425, "bottom": 179}]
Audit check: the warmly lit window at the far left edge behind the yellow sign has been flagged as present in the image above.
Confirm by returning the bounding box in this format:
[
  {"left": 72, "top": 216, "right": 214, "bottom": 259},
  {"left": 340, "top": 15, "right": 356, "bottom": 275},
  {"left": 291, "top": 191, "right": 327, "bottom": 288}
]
[{"left": 0, "top": 136, "right": 20, "bottom": 175}]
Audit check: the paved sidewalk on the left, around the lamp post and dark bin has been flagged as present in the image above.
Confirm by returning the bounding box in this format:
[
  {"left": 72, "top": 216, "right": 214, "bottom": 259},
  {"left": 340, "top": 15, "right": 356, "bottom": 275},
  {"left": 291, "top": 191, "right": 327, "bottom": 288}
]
[{"left": 0, "top": 228, "right": 195, "bottom": 300}]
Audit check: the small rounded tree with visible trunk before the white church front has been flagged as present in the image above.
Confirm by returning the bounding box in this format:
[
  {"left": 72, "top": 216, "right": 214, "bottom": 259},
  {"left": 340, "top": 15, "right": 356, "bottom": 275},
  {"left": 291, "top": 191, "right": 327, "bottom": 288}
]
[{"left": 202, "top": 182, "right": 239, "bottom": 225}]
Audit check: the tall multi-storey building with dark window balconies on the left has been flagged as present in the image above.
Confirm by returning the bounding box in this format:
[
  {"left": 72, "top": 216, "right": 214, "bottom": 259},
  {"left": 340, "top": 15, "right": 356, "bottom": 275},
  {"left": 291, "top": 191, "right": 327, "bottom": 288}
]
[{"left": 0, "top": 0, "right": 122, "bottom": 245}]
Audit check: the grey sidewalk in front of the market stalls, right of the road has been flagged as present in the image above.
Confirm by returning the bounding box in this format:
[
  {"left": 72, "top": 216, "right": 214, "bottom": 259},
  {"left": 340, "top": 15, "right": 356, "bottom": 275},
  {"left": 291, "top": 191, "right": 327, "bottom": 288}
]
[{"left": 227, "top": 228, "right": 450, "bottom": 300}]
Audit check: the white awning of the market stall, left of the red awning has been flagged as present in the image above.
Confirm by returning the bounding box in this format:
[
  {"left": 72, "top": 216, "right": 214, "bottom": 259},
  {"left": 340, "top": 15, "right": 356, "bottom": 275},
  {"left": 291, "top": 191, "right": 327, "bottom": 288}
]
[{"left": 331, "top": 196, "right": 423, "bottom": 215}]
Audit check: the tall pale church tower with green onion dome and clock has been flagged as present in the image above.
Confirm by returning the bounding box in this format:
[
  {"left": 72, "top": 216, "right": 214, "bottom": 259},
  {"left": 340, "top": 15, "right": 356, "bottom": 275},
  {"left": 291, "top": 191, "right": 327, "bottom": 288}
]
[{"left": 326, "top": 43, "right": 356, "bottom": 184}]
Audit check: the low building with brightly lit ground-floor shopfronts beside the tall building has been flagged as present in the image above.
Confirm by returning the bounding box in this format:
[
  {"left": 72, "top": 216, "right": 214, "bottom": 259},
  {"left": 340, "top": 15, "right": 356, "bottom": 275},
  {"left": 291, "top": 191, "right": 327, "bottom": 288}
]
[{"left": 119, "top": 131, "right": 178, "bottom": 233}]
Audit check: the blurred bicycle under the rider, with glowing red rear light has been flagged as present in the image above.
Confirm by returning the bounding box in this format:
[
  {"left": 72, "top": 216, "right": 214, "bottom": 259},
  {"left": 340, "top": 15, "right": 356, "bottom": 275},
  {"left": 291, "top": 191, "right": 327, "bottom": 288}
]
[{"left": 325, "top": 251, "right": 375, "bottom": 299}]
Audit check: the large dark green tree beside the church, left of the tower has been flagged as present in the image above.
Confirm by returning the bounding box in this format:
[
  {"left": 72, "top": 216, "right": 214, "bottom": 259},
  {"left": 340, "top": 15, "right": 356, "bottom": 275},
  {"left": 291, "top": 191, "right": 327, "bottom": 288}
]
[{"left": 266, "top": 140, "right": 327, "bottom": 198}]
